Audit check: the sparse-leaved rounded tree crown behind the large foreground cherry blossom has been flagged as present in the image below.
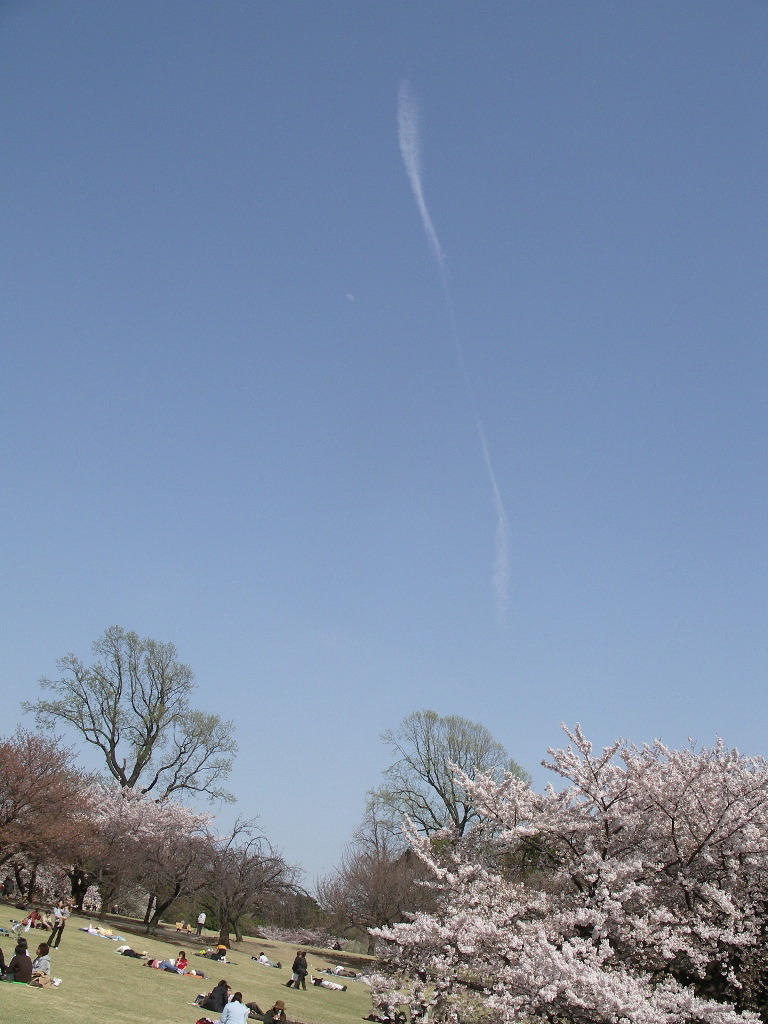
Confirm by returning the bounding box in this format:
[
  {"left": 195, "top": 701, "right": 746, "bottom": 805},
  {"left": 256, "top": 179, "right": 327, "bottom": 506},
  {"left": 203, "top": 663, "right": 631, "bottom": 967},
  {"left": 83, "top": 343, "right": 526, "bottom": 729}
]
[{"left": 370, "top": 711, "right": 527, "bottom": 836}]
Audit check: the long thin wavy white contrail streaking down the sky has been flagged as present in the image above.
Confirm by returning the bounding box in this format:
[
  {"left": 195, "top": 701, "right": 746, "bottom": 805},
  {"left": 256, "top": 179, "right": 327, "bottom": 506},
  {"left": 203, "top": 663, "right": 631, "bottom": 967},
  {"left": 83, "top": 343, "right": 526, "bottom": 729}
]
[{"left": 397, "top": 79, "right": 509, "bottom": 623}]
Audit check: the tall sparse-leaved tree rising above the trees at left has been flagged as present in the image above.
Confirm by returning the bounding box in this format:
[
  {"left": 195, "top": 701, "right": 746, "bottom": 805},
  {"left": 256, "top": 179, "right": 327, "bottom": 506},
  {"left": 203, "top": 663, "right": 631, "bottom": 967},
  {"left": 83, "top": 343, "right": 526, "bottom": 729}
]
[{"left": 23, "top": 626, "right": 237, "bottom": 800}]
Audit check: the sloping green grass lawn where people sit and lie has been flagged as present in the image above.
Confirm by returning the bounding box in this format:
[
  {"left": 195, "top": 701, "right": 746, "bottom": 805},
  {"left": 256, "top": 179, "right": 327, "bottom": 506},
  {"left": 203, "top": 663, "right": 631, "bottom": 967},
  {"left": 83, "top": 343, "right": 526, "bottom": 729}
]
[{"left": 0, "top": 908, "right": 378, "bottom": 1024}]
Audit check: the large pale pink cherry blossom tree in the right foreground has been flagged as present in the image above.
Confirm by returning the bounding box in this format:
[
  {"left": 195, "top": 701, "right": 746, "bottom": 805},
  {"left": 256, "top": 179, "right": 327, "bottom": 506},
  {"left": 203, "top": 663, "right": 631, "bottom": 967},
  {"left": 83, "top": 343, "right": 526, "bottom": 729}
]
[{"left": 374, "top": 727, "right": 768, "bottom": 1024}]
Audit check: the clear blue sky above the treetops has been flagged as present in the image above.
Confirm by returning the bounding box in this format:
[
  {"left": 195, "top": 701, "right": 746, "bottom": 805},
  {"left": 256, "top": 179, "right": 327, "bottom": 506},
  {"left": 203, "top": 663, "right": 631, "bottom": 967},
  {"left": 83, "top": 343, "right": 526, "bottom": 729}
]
[{"left": 0, "top": 0, "right": 768, "bottom": 884}]
